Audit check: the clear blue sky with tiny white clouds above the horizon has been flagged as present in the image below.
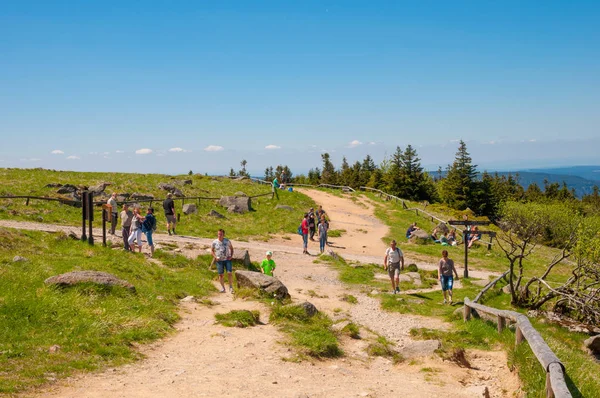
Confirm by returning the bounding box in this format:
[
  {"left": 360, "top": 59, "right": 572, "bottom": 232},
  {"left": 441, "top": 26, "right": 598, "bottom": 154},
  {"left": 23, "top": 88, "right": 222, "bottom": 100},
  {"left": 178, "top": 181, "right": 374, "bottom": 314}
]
[{"left": 0, "top": 0, "right": 600, "bottom": 175}]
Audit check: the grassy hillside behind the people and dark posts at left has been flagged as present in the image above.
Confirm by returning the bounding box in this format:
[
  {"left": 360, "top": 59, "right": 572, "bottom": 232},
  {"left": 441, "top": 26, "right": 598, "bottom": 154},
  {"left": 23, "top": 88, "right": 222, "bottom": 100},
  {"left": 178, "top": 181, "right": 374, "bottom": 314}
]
[{"left": 0, "top": 169, "right": 314, "bottom": 240}]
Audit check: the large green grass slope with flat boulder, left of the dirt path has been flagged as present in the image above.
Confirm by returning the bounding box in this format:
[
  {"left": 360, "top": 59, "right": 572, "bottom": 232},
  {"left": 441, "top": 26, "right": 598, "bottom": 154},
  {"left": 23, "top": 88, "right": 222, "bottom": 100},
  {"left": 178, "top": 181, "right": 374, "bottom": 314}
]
[{"left": 0, "top": 228, "right": 214, "bottom": 394}]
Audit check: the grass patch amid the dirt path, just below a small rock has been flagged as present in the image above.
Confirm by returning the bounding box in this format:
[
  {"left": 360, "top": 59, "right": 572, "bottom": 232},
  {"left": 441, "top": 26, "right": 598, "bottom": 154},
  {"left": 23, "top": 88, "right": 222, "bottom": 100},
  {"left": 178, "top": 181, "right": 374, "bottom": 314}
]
[{"left": 269, "top": 305, "right": 343, "bottom": 358}]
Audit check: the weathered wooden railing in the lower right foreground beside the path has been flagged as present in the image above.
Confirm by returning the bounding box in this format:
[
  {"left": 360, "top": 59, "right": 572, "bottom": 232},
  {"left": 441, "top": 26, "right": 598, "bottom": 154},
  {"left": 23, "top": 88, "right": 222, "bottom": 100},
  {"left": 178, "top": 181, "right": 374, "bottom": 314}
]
[{"left": 463, "top": 298, "right": 571, "bottom": 398}]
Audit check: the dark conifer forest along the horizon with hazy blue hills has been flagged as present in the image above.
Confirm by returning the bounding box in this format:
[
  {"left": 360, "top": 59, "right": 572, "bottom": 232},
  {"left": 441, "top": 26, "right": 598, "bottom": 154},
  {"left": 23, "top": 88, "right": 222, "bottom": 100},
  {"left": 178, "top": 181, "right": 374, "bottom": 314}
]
[{"left": 230, "top": 140, "right": 600, "bottom": 220}]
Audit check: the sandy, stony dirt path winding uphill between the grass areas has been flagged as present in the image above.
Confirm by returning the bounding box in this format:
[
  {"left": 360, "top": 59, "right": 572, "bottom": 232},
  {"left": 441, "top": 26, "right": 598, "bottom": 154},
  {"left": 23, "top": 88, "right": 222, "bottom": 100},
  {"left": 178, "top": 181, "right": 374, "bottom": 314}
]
[{"left": 5, "top": 191, "right": 518, "bottom": 397}]
